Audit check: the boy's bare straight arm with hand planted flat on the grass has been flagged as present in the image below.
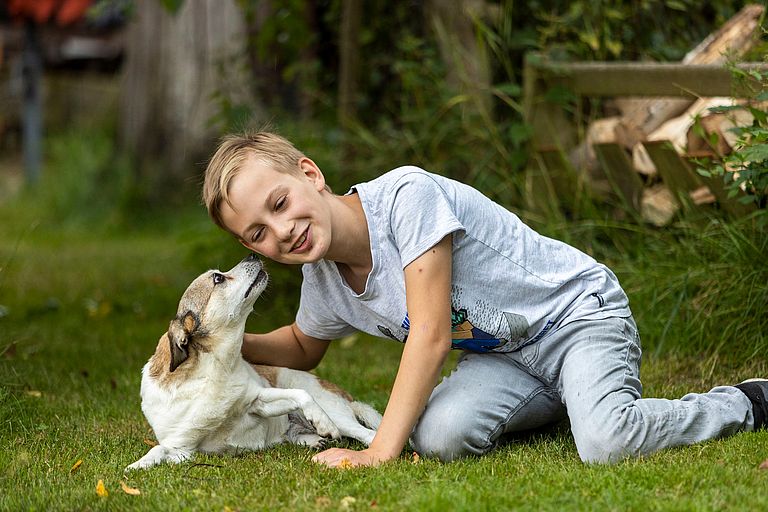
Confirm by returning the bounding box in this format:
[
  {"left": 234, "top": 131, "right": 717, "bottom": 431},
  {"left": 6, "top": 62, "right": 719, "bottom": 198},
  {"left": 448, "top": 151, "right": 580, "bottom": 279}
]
[{"left": 313, "top": 235, "right": 452, "bottom": 467}]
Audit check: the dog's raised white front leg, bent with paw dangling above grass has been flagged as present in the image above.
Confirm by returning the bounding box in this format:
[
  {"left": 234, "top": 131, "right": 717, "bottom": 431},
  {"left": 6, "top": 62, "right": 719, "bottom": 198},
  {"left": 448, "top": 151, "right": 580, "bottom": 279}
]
[{"left": 250, "top": 388, "right": 341, "bottom": 439}]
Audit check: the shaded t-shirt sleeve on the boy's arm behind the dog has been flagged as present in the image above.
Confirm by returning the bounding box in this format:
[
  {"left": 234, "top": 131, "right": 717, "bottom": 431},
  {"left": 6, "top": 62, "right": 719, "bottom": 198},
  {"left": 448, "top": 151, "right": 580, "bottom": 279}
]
[{"left": 296, "top": 267, "right": 356, "bottom": 340}]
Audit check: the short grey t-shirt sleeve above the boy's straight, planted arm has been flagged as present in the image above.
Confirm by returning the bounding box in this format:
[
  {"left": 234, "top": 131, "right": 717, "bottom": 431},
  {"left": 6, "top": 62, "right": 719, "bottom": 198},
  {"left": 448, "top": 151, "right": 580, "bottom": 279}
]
[{"left": 390, "top": 172, "right": 464, "bottom": 268}]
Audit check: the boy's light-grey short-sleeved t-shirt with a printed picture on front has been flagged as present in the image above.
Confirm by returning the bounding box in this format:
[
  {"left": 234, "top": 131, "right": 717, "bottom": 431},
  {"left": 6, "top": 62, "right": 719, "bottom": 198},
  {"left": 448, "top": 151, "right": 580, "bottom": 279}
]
[{"left": 296, "top": 166, "right": 631, "bottom": 352}]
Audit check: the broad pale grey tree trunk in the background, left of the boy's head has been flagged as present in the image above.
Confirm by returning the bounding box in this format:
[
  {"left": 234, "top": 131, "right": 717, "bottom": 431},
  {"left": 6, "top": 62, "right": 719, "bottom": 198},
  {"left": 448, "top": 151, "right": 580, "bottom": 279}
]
[{"left": 119, "top": 0, "right": 251, "bottom": 193}]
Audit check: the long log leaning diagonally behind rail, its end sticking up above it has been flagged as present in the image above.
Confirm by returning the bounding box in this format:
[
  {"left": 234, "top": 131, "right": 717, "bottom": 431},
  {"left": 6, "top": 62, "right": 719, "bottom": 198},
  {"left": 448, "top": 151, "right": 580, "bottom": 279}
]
[{"left": 616, "top": 4, "right": 765, "bottom": 149}]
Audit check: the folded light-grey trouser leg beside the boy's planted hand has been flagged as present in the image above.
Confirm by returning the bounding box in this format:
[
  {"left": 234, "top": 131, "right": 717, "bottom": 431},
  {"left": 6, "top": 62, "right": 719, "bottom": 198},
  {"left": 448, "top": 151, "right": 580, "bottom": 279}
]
[{"left": 411, "top": 353, "right": 565, "bottom": 462}]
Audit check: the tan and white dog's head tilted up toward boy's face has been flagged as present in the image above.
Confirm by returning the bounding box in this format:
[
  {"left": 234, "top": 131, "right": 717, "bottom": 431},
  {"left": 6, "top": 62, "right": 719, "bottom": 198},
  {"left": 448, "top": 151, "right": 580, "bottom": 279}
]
[{"left": 168, "top": 254, "right": 268, "bottom": 371}]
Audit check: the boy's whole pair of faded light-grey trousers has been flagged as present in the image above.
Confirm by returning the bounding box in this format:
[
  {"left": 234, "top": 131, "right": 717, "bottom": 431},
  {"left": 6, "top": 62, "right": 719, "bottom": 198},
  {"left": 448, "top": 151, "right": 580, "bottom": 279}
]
[{"left": 411, "top": 317, "right": 754, "bottom": 462}]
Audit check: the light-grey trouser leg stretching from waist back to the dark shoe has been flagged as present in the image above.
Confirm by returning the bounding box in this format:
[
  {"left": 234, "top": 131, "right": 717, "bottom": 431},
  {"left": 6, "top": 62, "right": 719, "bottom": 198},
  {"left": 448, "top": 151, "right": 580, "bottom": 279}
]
[{"left": 536, "top": 317, "right": 754, "bottom": 462}]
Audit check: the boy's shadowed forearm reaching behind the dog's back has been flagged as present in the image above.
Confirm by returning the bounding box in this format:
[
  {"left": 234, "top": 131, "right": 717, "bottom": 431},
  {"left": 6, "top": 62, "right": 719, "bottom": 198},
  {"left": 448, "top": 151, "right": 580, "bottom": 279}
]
[{"left": 242, "top": 323, "right": 330, "bottom": 370}]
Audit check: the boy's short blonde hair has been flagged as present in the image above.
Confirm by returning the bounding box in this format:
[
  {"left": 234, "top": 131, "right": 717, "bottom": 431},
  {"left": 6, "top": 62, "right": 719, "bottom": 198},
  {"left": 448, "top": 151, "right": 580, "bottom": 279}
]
[{"left": 203, "top": 131, "right": 305, "bottom": 231}]
